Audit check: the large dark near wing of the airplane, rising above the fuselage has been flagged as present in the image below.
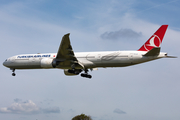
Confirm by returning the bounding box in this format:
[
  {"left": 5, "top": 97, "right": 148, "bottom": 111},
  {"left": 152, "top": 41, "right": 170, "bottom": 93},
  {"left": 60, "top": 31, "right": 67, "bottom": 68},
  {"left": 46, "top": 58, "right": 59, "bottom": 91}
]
[{"left": 56, "top": 33, "right": 81, "bottom": 67}]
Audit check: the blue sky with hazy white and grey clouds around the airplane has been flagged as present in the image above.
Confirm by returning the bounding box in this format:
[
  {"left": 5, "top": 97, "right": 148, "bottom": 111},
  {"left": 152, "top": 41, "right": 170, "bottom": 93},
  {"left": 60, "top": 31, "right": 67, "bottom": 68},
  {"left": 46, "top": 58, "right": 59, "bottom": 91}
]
[{"left": 0, "top": 0, "right": 180, "bottom": 120}]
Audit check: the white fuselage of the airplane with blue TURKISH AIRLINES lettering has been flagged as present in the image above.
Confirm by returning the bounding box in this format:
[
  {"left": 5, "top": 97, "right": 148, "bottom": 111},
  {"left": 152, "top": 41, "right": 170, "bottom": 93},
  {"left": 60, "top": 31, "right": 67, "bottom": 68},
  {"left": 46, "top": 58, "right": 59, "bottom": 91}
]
[{"left": 3, "top": 51, "right": 167, "bottom": 69}]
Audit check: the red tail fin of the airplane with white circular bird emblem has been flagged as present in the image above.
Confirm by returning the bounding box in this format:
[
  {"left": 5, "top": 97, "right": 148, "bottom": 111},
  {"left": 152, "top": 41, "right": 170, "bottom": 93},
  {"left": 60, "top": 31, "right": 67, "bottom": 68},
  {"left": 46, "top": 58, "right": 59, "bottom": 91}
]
[{"left": 138, "top": 25, "right": 168, "bottom": 51}]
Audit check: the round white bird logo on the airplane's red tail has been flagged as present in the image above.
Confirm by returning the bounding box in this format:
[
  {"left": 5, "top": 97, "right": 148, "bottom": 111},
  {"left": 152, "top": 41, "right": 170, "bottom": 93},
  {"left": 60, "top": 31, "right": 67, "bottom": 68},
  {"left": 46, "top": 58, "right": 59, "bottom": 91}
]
[{"left": 144, "top": 35, "right": 161, "bottom": 51}]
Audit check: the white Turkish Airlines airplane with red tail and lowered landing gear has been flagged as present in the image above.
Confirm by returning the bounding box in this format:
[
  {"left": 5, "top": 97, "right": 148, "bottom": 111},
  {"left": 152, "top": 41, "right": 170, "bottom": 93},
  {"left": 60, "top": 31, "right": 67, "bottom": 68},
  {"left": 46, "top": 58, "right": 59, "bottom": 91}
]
[{"left": 3, "top": 25, "right": 176, "bottom": 78}]
